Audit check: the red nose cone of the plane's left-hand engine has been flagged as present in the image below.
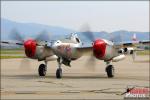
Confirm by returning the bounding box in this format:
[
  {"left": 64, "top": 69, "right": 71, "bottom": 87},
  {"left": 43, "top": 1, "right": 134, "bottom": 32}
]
[{"left": 24, "top": 39, "right": 36, "bottom": 58}]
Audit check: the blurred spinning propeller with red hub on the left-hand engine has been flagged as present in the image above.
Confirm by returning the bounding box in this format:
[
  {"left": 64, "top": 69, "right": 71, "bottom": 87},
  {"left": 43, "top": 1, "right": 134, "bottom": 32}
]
[{"left": 1, "top": 29, "right": 50, "bottom": 69}]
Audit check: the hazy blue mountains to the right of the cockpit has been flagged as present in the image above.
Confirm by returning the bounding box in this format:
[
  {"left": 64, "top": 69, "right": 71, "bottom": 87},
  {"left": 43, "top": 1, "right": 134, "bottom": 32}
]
[{"left": 78, "top": 30, "right": 150, "bottom": 43}]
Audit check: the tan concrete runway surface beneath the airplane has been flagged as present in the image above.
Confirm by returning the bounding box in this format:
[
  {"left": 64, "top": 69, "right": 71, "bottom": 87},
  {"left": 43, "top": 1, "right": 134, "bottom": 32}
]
[{"left": 1, "top": 56, "right": 149, "bottom": 99}]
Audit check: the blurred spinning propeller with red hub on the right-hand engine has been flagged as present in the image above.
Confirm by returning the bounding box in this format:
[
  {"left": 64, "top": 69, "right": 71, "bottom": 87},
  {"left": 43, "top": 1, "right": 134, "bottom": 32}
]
[{"left": 81, "top": 24, "right": 106, "bottom": 71}]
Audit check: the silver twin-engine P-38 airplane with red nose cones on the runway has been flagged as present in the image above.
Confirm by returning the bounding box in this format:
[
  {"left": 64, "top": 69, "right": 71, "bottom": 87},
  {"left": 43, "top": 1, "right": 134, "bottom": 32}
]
[{"left": 1, "top": 32, "right": 148, "bottom": 79}]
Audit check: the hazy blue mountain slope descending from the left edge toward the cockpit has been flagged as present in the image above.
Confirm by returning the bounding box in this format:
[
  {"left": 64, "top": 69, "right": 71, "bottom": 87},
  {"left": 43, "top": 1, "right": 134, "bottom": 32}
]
[{"left": 1, "top": 18, "right": 75, "bottom": 40}]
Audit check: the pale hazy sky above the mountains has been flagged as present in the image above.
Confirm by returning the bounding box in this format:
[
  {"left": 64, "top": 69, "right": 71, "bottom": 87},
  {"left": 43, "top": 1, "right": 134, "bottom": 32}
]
[{"left": 1, "top": 1, "right": 149, "bottom": 32}]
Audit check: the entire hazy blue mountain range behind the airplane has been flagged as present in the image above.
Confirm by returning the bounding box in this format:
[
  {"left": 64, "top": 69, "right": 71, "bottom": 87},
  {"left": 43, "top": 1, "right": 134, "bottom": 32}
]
[{"left": 1, "top": 18, "right": 150, "bottom": 46}]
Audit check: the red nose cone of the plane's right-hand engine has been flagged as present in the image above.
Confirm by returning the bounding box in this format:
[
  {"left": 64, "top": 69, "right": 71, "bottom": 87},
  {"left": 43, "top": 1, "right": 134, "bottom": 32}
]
[{"left": 93, "top": 39, "right": 106, "bottom": 59}]
